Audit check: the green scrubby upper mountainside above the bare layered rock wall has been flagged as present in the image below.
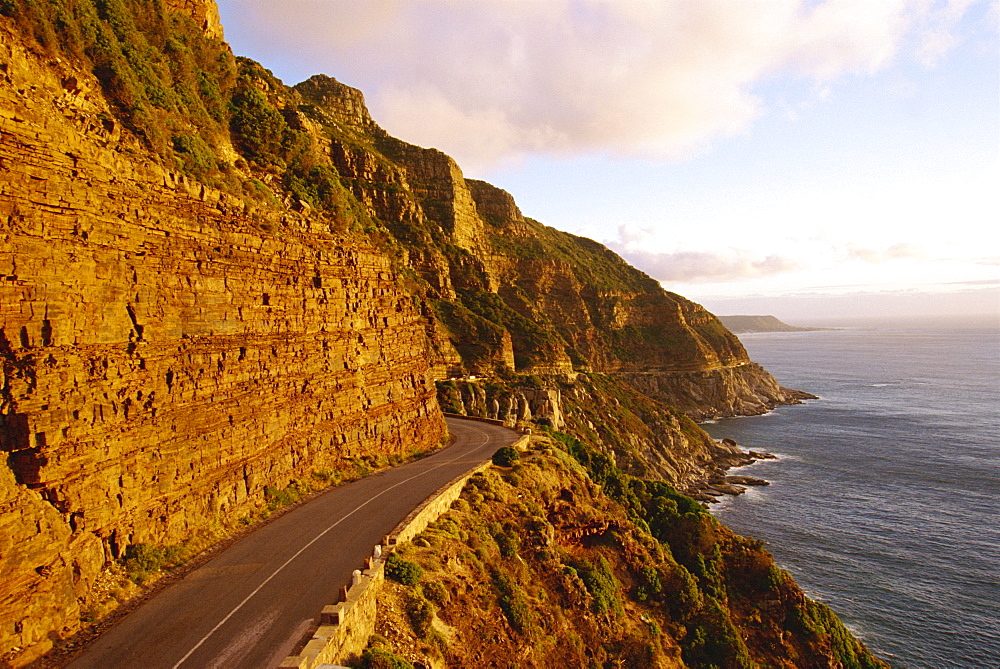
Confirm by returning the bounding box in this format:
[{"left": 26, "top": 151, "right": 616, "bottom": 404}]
[{"left": 0, "top": 0, "right": 745, "bottom": 373}]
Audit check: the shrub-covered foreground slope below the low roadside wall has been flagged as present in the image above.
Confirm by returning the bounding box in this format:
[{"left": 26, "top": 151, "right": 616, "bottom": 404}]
[{"left": 373, "top": 433, "right": 884, "bottom": 668}]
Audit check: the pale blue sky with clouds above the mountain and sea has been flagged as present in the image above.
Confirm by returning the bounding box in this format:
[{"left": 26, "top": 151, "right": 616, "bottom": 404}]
[{"left": 218, "top": 0, "right": 1000, "bottom": 324}]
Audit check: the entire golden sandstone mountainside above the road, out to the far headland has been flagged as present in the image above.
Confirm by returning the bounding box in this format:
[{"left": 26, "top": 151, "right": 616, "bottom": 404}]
[{"left": 0, "top": 0, "right": 808, "bottom": 662}]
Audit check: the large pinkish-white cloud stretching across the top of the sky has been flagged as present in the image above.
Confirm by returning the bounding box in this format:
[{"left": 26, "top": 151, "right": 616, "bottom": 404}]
[{"left": 220, "top": 0, "right": 984, "bottom": 172}]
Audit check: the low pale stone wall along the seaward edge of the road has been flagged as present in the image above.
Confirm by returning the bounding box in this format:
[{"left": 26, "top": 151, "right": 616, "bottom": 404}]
[{"left": 278, "top": 428, "right": 528, "bottom": 669}]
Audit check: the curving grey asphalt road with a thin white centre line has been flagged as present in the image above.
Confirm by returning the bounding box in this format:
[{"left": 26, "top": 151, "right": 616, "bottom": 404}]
[{"left": 68, "top": 418, "right": 518, "bottom": 669}]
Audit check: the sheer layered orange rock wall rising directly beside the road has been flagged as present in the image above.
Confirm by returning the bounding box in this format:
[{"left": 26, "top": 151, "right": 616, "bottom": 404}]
[{"left": 0, "top": 17, "right": 443, "bottom": 664}]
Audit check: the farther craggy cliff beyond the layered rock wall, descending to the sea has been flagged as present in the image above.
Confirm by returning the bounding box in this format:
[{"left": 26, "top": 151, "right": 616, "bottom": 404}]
[{"left": 295, "top": 76, "right": 800, "bottom": 418}]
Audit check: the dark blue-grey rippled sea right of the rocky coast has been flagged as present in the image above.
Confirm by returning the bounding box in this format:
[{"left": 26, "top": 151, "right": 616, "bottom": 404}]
[{"left": 704, "top": 320, "right": 1000, "bottom": 669}]
